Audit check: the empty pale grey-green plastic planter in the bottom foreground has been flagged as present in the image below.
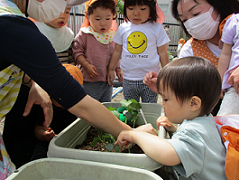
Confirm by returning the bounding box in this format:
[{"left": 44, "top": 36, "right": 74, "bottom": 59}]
[{"left": 7, "top": 158, "right": 162, "bottom": 180}]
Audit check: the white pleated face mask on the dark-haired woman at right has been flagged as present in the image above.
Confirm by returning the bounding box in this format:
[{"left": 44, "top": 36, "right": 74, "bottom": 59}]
[{"left": 184, "top": 7, "right": 220, "bottom": 40}]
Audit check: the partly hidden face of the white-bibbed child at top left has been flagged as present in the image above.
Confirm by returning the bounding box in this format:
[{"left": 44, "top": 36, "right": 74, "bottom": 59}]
[{"left": 45, "top": 7, "right": 71, "bottom": 28}]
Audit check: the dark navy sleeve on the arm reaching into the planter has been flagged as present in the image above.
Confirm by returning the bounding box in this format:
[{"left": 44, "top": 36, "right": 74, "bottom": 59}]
[{"left": 0, "top": 15, "right": 86, "bottom": 109}]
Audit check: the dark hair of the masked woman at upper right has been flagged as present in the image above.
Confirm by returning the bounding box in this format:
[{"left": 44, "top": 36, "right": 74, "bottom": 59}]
[{"left": 172, "top": 0, "right": 239, "bottom": 36}]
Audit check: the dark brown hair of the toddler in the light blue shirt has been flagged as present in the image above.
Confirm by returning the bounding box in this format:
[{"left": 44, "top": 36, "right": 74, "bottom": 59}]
[{"left": 157, "top": 56, "right": 222, "bottom": 116}]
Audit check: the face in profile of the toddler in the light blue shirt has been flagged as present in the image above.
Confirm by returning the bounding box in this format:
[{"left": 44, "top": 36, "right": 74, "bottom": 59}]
[{"left": 160, "top": 83, "right": 190, "bottom": 124}]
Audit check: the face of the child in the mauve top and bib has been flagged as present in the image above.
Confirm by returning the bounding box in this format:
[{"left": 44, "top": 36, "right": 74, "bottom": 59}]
[{"left": 88, "top": 7, "right": 114, "bottom": 34}]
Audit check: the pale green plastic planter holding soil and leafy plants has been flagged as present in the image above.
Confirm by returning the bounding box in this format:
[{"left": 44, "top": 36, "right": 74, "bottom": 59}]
[{"left": 48, "top": 102, "right": 166, "bottom": 171}]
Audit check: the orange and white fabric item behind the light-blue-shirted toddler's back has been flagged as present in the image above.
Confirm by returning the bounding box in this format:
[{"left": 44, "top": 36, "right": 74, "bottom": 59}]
[{"left": 214, "top": 115, "right": 239, "bottom": 180}]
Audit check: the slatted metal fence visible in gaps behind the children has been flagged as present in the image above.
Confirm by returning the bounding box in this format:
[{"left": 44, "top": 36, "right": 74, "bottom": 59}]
[{"left": 68, "top": 12, "right": 186, "bottom": 52}]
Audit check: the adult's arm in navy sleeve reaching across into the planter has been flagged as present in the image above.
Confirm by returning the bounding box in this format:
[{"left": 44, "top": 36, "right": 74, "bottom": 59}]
[{"left": 0, "top": 16, "right": 131, "bottom": 137}]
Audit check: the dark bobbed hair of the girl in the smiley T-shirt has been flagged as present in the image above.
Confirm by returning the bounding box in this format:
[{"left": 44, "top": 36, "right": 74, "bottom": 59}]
[{"left": 124, "top": 0, "right": 158, "bottom": 22}]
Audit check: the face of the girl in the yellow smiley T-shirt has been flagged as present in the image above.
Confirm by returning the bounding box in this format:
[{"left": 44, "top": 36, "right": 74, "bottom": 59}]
[{"left": 126, "top": 5, "right": 150, "bottom": 25}]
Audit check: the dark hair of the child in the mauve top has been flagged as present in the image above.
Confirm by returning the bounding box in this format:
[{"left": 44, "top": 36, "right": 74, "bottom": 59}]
[{"left": 86, "top": 0, "right": 117, "bottom": 19}]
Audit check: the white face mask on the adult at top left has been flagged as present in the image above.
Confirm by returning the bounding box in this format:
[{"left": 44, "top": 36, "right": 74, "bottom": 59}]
[{"left": 27, "top": 0, "right": 67, "bottom": 22}]
